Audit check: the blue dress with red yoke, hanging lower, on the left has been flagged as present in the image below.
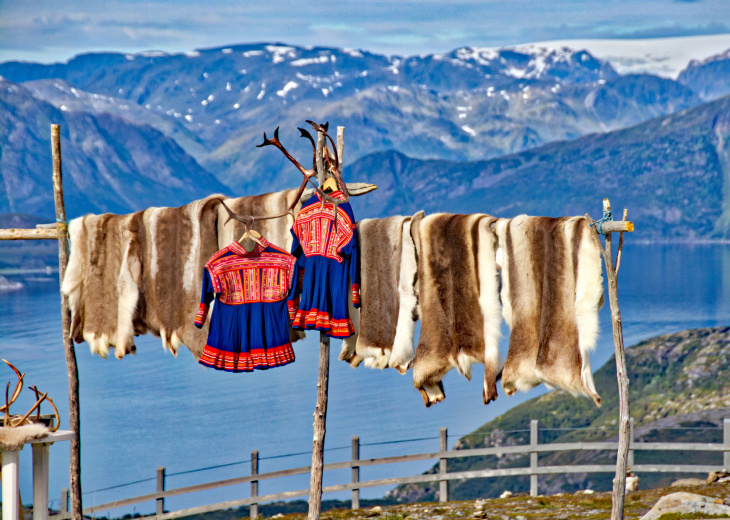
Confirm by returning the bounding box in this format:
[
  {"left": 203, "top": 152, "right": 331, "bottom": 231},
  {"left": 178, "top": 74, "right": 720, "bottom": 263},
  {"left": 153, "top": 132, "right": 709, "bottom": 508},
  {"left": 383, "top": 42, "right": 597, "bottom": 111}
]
[{"left": 195, "top": 237, "right": 298, "bottom": 372}]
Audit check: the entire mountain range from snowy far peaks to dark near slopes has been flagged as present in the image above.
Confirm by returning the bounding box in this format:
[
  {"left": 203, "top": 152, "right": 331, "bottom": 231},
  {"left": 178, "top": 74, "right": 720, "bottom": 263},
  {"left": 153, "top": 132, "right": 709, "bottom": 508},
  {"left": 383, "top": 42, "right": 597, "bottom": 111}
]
[{"left": 0, "top": 43, "right": 730, "bottom": 239}]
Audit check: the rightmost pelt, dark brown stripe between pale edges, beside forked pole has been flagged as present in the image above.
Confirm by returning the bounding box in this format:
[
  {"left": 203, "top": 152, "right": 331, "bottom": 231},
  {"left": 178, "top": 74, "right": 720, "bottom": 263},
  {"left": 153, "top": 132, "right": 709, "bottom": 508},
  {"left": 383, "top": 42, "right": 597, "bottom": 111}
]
[{"left": 496, "top": 215, "right": 603, "bottom": 406}]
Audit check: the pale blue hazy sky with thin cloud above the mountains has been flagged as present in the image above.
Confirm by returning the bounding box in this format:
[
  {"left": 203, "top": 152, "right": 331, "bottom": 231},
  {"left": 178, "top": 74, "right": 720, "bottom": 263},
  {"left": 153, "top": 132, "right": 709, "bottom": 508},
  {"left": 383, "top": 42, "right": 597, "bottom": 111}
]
[{"left": 0, "top": 0, "right": 730, "bottom": 62}]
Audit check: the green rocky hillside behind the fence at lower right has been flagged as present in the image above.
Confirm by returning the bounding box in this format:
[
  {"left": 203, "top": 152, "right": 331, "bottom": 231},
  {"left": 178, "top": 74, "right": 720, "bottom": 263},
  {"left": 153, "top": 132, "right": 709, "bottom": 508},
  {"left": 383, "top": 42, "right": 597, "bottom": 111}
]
[{"left": 387, "top": 327, "right": 730, "bottom": 502}]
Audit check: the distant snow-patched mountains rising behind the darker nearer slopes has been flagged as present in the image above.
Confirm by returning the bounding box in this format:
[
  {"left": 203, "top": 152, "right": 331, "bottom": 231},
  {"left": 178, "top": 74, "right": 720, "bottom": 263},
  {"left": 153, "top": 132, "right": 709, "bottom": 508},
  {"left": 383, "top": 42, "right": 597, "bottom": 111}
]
[{"left": 0, "top": 36, "right": 726, "bottom": 215}]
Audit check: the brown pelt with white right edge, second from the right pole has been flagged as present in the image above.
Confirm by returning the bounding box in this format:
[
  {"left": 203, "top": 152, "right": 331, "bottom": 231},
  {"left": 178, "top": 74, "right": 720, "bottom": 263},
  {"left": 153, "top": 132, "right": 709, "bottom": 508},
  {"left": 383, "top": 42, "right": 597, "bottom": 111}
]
[{"left": 411, "top": 213, "right": 502, "bottom": 406}]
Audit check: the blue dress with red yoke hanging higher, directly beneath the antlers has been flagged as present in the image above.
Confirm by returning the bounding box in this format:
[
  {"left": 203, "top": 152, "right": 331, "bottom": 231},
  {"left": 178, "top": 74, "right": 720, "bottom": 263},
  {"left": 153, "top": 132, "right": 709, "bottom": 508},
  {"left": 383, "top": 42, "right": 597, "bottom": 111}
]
[{"left": 289, "top": 191, "right": 360, "bottom": 338}]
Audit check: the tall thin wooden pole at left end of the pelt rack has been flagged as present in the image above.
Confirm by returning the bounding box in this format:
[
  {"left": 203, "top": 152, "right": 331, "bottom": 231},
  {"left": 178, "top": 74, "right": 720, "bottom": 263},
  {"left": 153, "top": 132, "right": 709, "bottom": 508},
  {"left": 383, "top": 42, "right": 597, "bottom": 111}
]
[{"left": 51, "top": 125, "right": 83, "bottom": 520}]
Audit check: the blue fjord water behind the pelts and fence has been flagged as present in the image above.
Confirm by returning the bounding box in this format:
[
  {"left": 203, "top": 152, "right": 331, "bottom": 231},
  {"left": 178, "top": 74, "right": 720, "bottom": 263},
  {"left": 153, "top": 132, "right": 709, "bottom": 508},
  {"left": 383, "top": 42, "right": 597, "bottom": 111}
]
[{"left": 0, "top": 244, "right": 730, "bottom": 516}]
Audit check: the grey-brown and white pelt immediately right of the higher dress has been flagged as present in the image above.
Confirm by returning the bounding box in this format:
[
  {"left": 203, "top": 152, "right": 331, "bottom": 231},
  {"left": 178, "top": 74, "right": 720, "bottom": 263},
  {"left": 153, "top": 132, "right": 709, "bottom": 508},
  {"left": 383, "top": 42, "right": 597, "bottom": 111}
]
[{"left": 340, "top": 212, "right": 418, "bottom": 374}]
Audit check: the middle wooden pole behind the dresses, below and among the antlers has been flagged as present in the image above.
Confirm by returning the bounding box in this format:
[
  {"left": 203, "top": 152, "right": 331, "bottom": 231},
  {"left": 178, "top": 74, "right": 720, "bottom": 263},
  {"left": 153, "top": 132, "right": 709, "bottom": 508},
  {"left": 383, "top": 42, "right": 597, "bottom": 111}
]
[{"left": 308, "top": 126, "right": 345, "bottom": 520}]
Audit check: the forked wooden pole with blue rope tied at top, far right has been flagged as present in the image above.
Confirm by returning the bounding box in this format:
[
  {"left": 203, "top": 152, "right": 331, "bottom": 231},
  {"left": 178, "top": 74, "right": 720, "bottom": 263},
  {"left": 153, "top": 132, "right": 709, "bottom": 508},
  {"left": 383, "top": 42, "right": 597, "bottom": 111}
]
[{"left": 586, "top": 199, "right": 634, "bottom": 520}]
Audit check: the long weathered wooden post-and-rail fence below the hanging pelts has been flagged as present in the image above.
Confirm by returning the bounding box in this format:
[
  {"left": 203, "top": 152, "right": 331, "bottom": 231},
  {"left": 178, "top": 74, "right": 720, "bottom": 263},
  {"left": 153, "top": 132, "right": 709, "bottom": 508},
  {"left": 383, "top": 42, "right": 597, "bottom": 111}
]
[{"left": 50, "top": 419, "right": 730, "bottom": 520}]
